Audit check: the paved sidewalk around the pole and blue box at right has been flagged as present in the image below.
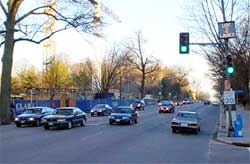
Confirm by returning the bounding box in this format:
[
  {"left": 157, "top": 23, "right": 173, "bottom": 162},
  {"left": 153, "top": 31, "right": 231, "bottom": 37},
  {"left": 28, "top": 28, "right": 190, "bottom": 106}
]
[{"left": 217, "top": 106, "right": 250, "bottom": 147}]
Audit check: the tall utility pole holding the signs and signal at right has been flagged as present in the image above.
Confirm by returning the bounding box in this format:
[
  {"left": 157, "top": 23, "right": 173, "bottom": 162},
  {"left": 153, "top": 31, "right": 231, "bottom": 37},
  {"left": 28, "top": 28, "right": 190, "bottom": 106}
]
[{"left": 221, "top": 0, "right": 233, "bottom": 137}]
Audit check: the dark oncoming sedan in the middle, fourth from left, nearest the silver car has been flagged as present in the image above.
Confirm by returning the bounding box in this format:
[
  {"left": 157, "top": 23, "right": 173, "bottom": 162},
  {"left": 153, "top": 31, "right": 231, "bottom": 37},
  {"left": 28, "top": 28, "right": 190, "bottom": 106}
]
[{"left": 109, "top": 106, "right": 138, "bottom": 125}]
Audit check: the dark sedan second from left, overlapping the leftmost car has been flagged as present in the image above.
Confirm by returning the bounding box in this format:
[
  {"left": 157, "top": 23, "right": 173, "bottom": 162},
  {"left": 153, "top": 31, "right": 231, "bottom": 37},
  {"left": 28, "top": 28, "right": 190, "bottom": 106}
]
[{"left": 42, "top": 107, "right": 87, "bottom": 130}]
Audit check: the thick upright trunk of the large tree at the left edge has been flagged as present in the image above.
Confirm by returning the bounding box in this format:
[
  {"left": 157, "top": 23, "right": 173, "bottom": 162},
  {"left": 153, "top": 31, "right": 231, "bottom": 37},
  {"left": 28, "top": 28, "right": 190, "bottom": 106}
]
[{"left": 0, "top": 20, "right": 14, "bottom": 124}]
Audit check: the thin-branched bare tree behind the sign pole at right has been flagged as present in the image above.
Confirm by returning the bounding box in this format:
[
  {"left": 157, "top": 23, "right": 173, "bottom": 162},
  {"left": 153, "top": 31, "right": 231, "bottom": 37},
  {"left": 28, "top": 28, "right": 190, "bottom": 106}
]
[{"left": 187, "top": 0, "right": 250, "bottom": 104}]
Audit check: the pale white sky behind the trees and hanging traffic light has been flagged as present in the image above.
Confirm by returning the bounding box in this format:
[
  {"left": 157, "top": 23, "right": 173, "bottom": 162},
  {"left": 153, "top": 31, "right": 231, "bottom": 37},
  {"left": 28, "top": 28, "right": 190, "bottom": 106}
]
[{"left": 0, "top": 0, "right": 214, "bottom": 96}]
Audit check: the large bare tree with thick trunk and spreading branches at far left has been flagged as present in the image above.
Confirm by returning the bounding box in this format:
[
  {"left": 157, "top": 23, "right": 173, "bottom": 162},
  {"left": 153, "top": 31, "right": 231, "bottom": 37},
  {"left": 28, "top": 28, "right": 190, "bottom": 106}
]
[{"left": 0, "top": 0, "right": 94, "bottom": 124}]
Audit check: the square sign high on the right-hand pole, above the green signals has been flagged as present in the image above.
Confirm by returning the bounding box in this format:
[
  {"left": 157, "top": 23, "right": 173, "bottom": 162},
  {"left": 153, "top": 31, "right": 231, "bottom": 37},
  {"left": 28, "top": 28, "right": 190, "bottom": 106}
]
[{"left": 218, "top": 21, "right": 236, "bottom": 39}]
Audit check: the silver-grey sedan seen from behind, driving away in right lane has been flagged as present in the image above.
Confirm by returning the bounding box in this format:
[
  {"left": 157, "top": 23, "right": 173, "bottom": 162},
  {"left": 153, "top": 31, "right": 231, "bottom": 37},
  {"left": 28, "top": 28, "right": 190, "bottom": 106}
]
[{"left": 171, "top": 111, "right": 200, "bottom": 134}]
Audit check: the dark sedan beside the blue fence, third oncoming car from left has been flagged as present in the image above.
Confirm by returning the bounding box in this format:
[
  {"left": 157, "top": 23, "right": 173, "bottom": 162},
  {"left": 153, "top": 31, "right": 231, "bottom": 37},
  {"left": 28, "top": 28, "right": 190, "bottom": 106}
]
[{"left": 90, "top": 104, "right": 113, "bottom": 116}]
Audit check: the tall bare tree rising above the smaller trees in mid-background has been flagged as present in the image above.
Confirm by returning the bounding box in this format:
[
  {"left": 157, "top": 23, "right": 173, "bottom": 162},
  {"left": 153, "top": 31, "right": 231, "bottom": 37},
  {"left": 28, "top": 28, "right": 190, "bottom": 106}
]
[{"left": 125, "top": 31, "right": 160, "bottom": 98}]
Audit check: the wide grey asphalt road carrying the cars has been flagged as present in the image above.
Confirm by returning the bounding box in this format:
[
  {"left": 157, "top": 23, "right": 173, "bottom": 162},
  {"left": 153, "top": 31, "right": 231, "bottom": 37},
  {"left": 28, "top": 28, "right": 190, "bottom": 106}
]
[{"left": 0, "top": 103, "right": 250, "bottom": 164}]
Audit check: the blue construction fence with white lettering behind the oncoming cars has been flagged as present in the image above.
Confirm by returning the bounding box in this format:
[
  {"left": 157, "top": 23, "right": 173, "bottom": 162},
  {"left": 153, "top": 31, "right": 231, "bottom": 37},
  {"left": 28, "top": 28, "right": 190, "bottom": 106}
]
[{"left": 14, "top": 99, "right": 157, "bottom": 115}]
